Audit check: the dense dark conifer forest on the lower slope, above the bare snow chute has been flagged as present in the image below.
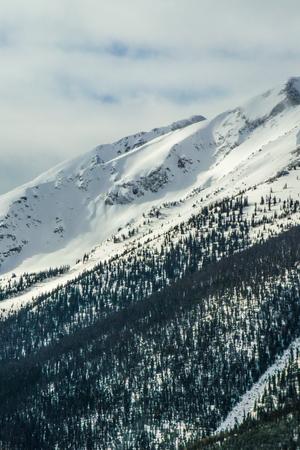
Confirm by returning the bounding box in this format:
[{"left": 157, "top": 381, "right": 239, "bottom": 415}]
[{"left": 0, "top": 195, "right": 300, "bottom": 450}]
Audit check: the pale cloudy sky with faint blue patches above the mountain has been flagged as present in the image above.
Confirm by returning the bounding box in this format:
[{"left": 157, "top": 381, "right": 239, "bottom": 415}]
[{"left": 0, "top": 0, "right": 300, "bottom": 193}]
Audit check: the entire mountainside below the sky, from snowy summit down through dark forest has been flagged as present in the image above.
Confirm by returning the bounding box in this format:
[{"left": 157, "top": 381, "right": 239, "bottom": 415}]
[{"left": 0, "top": 78, "right": 300, "bottom": 450}]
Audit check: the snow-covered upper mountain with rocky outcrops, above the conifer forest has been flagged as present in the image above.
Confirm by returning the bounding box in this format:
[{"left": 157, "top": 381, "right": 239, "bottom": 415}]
[{"left": 0, "top": 78, "right": 300, "bottom": 274}]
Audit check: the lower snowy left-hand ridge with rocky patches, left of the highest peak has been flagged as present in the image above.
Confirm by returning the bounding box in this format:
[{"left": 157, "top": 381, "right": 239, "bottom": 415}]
[{"left": 0, "top": 116, "right": 204, "bottom": 273}]
